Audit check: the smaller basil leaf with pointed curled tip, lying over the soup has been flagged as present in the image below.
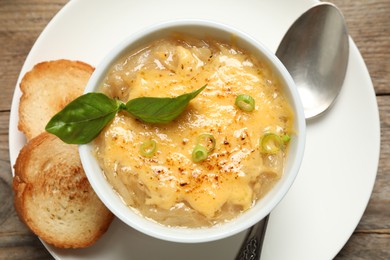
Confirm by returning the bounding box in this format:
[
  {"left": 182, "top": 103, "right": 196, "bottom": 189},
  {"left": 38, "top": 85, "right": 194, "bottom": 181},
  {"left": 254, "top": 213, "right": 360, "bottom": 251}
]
[{"left": 126, "top": 85, "right": 206, "bottom": 123}]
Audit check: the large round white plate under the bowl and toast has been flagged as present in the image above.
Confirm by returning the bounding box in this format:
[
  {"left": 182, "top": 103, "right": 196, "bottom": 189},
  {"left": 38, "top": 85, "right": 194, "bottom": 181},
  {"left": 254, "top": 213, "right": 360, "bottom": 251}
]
[{"left": 9, "top": 0, "right": 380, "bottom": 260}]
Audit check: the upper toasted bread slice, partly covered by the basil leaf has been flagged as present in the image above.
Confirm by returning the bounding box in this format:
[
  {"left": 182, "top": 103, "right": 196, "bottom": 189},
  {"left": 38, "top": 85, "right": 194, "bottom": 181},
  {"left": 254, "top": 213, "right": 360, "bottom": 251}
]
[{"left": 18, "top": 60, "right": 94, "bottom": 140}]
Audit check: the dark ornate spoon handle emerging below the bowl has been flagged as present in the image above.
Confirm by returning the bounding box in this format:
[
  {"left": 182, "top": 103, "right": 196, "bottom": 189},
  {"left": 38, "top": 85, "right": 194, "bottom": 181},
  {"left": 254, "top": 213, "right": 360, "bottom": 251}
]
[{"left": 235, "top": 215, "right": 269, "bottom": 260}]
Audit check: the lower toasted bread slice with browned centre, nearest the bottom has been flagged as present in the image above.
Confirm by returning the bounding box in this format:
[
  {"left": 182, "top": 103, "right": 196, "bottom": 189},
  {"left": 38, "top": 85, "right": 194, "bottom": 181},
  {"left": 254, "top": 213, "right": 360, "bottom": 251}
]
[{"left": 13, "top": 132, "right": 113, "bottom": 248}]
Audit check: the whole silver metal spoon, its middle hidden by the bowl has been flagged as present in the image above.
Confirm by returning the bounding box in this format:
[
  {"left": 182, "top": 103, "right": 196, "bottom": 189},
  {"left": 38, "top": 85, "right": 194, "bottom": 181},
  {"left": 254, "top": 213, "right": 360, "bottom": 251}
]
[{"left": 236, "top": 3, "right": 349, "bottom": 260}]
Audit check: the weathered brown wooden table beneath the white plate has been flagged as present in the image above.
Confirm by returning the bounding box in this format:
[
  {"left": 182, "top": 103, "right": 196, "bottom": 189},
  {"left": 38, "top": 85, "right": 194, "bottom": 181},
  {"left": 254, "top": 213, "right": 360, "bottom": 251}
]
[{"left": 0, "top": 0, "right": 390, "bottom": 259}]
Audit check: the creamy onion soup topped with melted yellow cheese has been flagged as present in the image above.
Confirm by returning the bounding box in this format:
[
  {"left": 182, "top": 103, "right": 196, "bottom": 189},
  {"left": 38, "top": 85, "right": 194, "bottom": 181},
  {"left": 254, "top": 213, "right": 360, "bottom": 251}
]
[{"left": 94, "top": 36, "right": 294, "bottom": 227}]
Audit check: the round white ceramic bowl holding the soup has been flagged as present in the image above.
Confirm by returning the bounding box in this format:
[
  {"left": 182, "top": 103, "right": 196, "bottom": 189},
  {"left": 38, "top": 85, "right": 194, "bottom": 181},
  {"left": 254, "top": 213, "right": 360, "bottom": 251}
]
[{"left": 79, "top": 20, "right": 306, "bottom": 243}]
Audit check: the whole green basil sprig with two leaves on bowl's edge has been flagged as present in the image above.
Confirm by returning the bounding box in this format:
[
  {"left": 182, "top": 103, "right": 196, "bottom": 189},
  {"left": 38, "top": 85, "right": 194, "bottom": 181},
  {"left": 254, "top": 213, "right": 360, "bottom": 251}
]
[{"left": 45, "top": 85, "right": 206, "bottom": 144}]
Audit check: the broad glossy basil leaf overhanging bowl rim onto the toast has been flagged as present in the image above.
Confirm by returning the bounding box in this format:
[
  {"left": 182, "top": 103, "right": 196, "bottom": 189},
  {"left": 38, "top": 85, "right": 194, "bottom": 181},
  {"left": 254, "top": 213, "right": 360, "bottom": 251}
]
[{"left": 45, "top": 93, "right": 120, "bottom": 144}]
